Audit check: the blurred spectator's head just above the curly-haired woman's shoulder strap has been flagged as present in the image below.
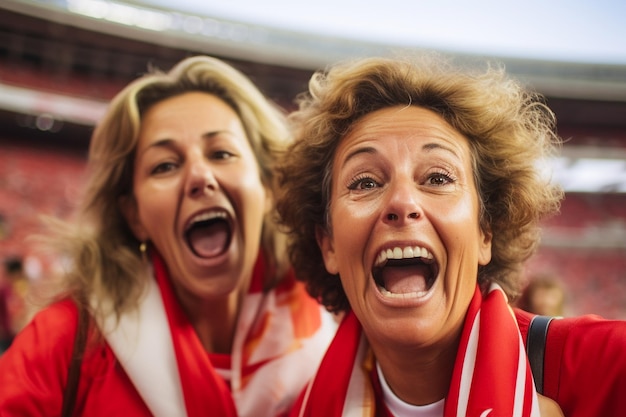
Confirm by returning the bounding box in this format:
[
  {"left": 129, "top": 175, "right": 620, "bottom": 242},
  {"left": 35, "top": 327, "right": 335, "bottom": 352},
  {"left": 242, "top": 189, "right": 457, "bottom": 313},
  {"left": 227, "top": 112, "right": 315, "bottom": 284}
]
[{"left": 517, "top": 274, "right": 566, "bottom": 317}]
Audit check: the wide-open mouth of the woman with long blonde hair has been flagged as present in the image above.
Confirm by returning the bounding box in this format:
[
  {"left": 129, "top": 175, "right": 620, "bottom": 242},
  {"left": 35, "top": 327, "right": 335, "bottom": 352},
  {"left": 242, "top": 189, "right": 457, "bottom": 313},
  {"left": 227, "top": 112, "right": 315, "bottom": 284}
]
[{"left": 185, "top": 210, "right": 232, "bottom": 258}]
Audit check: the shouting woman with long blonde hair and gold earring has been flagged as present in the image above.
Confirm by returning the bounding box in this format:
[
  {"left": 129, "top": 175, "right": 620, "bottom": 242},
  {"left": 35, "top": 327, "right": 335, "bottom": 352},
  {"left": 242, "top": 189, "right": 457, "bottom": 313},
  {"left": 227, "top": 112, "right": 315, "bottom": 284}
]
[{"left": 0, "top": 56, "right": 336, "bottom": 417}]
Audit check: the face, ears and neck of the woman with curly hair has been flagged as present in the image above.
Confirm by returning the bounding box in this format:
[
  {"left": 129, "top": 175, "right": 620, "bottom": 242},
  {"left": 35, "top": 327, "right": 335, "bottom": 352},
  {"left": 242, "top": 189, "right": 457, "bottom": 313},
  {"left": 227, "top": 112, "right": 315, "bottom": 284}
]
[{"left": 318, "top": 106, "right": 491, "bottom": 405}]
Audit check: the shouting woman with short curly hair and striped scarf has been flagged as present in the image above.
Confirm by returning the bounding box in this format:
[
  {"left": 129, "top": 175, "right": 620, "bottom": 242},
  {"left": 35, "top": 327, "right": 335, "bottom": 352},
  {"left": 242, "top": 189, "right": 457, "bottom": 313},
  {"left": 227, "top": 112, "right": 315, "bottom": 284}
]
[{"left": 278, "top": 56, "right": 626, "bottom": 417}]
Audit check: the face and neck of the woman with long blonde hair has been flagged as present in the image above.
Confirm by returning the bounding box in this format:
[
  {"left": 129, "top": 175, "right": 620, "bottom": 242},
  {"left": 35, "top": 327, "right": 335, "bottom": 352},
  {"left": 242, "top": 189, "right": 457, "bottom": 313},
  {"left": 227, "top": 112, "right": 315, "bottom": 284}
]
[{"left": 122, "top": 92, "right": 269, "bottom": 352}]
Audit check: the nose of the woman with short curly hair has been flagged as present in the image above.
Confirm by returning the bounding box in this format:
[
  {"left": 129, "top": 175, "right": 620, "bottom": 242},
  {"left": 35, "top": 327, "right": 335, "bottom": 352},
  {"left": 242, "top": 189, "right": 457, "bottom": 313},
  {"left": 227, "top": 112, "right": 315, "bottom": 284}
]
[{"left": 383, "top": 179, "right": 422, "bottom": 225}]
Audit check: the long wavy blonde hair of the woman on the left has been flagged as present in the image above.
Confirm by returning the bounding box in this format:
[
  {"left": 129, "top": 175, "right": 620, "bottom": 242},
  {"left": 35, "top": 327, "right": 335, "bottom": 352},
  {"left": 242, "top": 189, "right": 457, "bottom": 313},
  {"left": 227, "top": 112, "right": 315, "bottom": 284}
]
[{"left": 43, "top": 56, "right": 290, "bottom": 316}]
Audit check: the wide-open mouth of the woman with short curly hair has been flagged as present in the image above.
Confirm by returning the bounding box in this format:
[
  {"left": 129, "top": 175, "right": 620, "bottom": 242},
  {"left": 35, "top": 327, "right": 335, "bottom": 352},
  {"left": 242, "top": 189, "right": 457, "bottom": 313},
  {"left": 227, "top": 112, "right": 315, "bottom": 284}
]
[{"left": 372, "top": 246, "right": 439, "bottom": 298}]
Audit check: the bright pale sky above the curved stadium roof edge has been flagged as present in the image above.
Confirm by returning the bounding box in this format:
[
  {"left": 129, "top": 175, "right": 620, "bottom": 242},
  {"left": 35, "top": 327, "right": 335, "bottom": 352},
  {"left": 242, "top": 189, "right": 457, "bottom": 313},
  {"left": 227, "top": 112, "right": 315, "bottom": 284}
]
[{"left": 136, "top": 0, "right": 626, "bottom": 64}]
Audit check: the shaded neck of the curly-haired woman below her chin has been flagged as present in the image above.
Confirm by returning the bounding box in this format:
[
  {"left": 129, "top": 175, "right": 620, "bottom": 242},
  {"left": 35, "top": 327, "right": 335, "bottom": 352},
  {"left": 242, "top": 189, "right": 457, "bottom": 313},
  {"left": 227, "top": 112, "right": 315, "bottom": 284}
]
[{"left": 372, "top": 334, "right": 458, "bottom": 405}]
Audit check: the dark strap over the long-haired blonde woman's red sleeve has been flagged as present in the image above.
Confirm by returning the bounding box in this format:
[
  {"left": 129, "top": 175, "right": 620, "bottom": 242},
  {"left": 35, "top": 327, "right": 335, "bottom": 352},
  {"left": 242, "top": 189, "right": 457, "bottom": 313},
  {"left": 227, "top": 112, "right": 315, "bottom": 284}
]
[{"left": 61, "top": 303, "right": 89, "bottom": 417}]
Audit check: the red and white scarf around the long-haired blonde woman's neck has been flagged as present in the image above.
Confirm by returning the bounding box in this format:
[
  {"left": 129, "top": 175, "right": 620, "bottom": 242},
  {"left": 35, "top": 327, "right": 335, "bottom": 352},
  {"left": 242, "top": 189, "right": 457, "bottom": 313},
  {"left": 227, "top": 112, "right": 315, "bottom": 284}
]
[{"left": 100, "top": 250, "right": 337, "bottom": 417}]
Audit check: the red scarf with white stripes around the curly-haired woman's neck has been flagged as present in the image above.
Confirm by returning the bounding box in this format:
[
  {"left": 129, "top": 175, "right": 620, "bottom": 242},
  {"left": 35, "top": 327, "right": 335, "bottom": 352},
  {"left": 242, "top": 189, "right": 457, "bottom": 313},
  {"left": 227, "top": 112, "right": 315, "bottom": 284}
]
[{"left": 291, "top": 284, "right": 539, "bottom": 417}]
